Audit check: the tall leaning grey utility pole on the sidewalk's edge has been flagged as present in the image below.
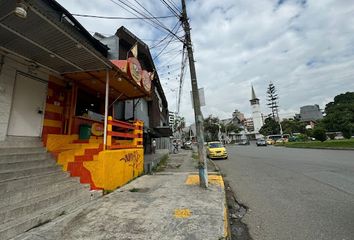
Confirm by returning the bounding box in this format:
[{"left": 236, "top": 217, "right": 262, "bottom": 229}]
[{"left": 181, "top": 0, "right": 208, "bottom": 188}]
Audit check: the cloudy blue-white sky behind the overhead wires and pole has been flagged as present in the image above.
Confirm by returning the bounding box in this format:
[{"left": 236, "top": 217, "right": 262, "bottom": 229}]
[{"left": 58, "top": 0, "right": 354, "bottom": 123}]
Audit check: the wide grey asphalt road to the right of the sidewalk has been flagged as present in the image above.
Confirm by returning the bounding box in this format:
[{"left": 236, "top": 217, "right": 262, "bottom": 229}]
[{"left": 216, "top": 145, "right": 354, "bottom": 240}]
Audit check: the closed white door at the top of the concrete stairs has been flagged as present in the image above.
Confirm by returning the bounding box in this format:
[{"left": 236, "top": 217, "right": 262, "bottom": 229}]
[{"left": 7, "top": 74, "right": 47, "bottom": 137}]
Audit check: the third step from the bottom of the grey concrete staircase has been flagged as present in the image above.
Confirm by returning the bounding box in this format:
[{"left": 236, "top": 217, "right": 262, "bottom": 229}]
[{"left": 0, "top": 177, "right": 80, "bottom": 209}]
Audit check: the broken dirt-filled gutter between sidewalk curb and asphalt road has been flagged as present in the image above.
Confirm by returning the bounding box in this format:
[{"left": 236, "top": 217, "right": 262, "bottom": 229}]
[{"left": 224, "top": 179, "right": 252, "bottom": 240}]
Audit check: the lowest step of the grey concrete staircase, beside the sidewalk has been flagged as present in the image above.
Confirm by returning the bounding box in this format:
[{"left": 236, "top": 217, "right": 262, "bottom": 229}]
[{"left": 0, "top": 189, "right": 94, "bottom": 240}]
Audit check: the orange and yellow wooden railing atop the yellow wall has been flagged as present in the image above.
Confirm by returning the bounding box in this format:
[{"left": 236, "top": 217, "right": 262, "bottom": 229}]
[{"left": 107, "top": 116, "right": 144, "bottom": 149}]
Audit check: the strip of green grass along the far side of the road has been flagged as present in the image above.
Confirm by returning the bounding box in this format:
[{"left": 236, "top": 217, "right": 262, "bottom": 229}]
[{"left": 276, "top": 139, "right": 354, "bottom": 149}]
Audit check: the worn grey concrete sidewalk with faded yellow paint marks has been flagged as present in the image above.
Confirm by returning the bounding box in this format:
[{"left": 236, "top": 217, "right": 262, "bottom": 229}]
[{"left": 15, "top": 151, "right": 227, "bottom": 240}]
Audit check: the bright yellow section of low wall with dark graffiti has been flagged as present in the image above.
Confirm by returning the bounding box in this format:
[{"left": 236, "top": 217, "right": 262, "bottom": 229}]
[{"left": 84, "top": 148, "right": 144, "bottom": 190}]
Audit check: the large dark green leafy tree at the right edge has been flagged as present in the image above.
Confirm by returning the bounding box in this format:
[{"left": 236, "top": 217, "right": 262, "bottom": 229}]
[{"left": 321, "top": 92, "right": 354, "bottom": 138}]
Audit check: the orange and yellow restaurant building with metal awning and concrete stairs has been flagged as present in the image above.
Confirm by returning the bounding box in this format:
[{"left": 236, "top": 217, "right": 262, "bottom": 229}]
[{"left": 0, "top": 0, "right": 168, "bottom": 239}]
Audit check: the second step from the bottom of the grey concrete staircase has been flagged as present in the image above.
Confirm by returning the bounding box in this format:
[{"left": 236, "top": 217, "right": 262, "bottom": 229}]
[{"left": 0, "top": 184, "right": 89, "bottom": 224}]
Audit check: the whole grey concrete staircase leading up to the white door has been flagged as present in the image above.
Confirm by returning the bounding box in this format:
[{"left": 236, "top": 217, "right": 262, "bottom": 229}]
[{"left": 0, "top": 137, "right": 101, "bottom": 240}]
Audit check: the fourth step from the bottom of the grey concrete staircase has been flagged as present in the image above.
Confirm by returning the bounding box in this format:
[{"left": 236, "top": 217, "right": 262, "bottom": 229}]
[{"left": 0, "top": 171, "right": 70, "bottom": 195}]
